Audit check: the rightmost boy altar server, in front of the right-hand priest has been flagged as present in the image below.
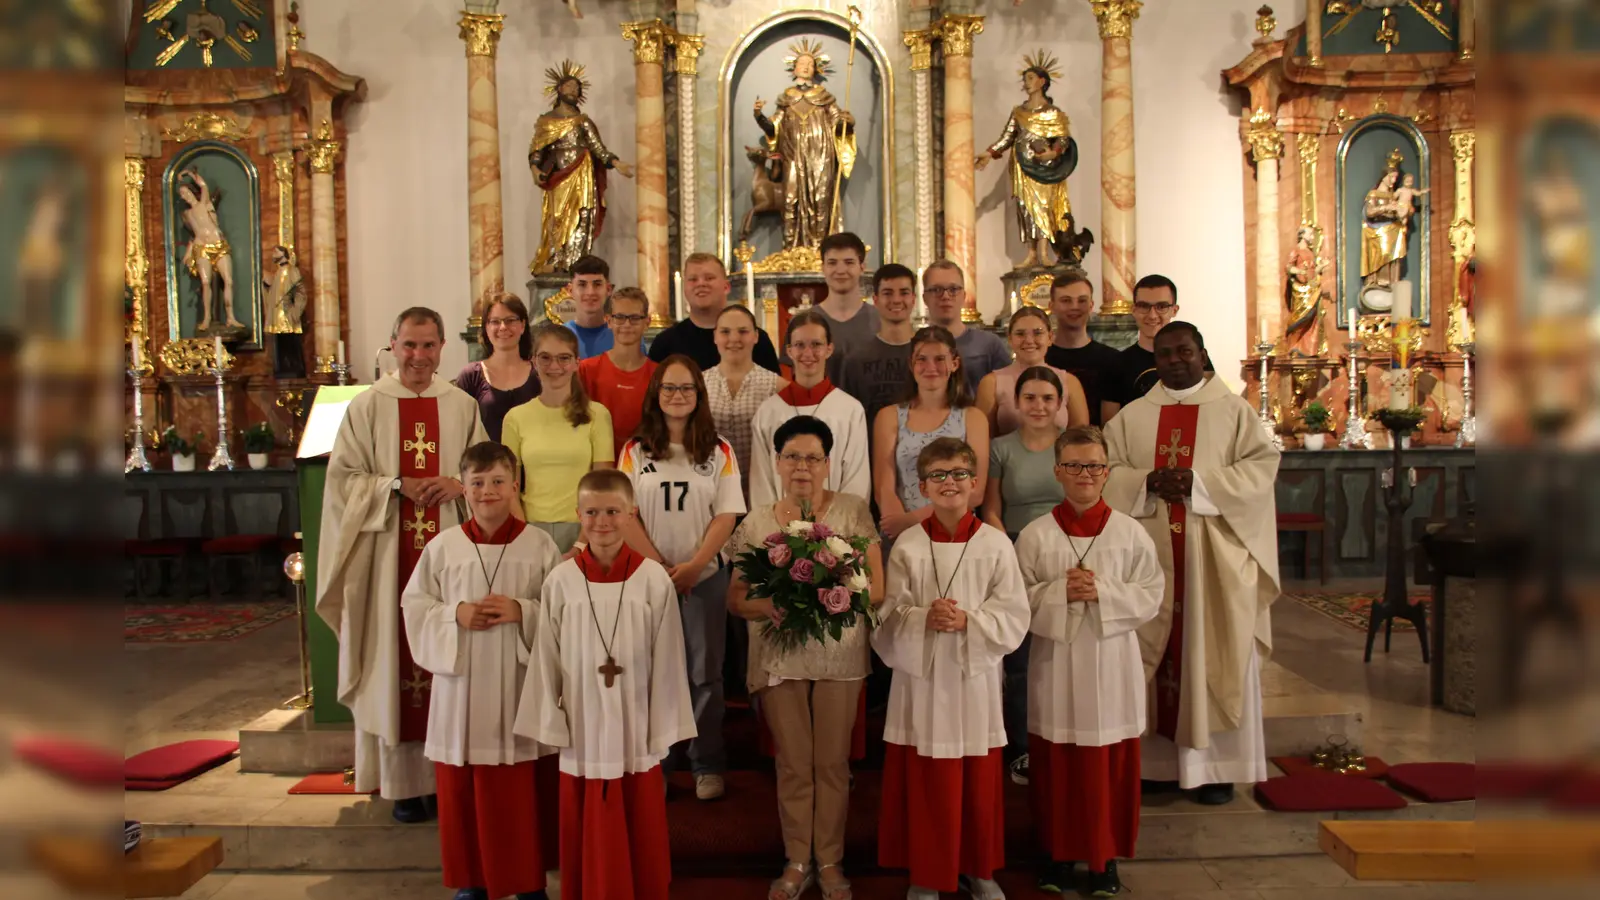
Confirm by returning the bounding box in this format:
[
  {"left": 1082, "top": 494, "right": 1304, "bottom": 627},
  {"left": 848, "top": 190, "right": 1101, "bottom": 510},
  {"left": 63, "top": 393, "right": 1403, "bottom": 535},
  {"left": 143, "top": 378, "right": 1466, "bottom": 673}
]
[{"left": 1016, "top": 426, "right": 1166, "bottom": 897}]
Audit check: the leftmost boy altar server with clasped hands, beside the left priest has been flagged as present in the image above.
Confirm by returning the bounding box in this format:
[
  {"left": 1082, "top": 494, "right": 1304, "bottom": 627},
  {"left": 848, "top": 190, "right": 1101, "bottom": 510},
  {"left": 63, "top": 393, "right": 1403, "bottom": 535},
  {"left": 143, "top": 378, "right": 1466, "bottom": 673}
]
[{"left": 400, "top": 444, "right": 562, "bottom": 900}]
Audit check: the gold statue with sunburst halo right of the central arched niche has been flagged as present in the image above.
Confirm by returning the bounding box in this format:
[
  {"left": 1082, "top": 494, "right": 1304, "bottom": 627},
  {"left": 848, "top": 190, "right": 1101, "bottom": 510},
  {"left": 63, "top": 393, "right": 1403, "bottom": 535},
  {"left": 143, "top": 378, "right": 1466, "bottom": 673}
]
[{"left": 973, "top": 50, "right": 1094, "bottom": 269}]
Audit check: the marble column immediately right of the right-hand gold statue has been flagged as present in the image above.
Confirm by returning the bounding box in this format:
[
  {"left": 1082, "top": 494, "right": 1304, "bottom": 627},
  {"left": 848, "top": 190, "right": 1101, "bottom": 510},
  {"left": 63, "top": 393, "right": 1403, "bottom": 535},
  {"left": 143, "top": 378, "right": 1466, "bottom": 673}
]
[{"left": 1090, "top": 0, "right": 1144, "bottom": 315}]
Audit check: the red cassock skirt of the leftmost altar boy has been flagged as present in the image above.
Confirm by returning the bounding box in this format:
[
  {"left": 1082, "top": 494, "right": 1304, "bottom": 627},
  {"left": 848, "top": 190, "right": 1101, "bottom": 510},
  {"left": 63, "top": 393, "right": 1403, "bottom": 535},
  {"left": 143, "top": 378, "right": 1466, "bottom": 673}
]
[{"left": 434, "top": 756, "right": 560, "bottom": 897}]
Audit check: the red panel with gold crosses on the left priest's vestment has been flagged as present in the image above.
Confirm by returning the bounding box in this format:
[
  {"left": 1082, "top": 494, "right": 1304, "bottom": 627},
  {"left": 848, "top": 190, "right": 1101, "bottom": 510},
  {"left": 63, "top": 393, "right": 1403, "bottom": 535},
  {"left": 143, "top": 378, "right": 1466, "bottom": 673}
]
[{"left": 395, "top": 397, "right": 440, "bottom": 740}]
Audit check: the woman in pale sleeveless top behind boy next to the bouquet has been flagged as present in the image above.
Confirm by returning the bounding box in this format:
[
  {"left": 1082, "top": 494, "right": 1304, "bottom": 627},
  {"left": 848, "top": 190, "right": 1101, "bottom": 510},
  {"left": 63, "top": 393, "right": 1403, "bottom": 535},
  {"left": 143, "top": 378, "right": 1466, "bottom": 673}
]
[{"left": 872, "top": 325, "right": 989, "bottom": 540}]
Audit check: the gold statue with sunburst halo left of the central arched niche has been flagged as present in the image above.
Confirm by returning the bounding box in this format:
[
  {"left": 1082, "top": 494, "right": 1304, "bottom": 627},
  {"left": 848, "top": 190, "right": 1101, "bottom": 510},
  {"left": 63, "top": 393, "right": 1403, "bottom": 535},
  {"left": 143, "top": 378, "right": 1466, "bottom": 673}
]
[{"left": 528, "top": 59, "right": 634, "bottom": 274}]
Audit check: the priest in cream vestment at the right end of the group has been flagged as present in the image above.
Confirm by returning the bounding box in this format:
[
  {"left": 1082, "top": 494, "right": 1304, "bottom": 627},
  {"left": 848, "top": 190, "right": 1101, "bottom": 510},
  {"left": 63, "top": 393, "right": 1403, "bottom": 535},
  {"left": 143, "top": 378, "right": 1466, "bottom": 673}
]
[{"left": 1106, "top": 322, "right": 1278, "bottom": 806}]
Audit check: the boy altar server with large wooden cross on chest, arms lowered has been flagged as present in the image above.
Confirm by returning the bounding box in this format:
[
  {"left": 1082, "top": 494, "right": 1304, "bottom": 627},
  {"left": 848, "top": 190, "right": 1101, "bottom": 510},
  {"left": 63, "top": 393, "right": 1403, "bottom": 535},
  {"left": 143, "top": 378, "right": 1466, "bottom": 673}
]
[{"left": 515, "top": 469, "right": 694, "bottom": 900}]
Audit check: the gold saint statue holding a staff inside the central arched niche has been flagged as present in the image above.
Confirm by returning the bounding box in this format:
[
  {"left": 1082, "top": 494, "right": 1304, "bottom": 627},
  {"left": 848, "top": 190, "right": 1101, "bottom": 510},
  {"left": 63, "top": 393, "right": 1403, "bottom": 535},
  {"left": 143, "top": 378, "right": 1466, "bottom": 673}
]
[{"left": 755, "top": 40, "right": 856, "bottom": 250}]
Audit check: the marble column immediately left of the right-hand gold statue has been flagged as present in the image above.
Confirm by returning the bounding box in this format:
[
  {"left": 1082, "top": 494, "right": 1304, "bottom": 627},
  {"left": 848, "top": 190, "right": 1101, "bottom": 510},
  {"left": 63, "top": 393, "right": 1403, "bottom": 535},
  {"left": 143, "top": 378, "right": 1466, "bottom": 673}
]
[{"left": 934, "top": 16, "right": 984, "bottom": 322}]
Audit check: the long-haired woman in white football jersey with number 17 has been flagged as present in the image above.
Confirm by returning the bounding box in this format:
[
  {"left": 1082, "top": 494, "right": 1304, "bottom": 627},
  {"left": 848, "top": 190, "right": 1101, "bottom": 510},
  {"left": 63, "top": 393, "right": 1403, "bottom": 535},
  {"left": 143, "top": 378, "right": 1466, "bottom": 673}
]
[{"left": 616, "top": 354, "right": 744, "bottom": 801}]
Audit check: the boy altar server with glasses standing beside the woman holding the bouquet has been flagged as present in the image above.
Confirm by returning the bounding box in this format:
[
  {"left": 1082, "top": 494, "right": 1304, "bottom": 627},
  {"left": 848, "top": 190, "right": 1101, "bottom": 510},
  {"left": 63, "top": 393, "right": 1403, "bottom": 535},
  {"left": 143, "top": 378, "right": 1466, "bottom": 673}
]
[{"left": 872, "top": 437, "right": 1027, "bottom": 900}]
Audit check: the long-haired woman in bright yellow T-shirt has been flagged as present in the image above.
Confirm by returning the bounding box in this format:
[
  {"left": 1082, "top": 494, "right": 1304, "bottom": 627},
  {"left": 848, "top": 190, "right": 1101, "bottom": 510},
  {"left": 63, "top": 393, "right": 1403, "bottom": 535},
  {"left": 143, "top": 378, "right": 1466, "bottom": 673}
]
[{"left": 501, "top": 325, "right": 614, "bottom": 554}]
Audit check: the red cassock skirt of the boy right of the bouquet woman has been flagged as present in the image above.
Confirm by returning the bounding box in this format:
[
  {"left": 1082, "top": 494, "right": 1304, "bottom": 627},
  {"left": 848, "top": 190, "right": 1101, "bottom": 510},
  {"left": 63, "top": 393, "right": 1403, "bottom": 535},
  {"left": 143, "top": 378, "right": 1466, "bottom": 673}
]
[{"left": 878, "top": 743, "right": 1005, "bottom": 890}]
